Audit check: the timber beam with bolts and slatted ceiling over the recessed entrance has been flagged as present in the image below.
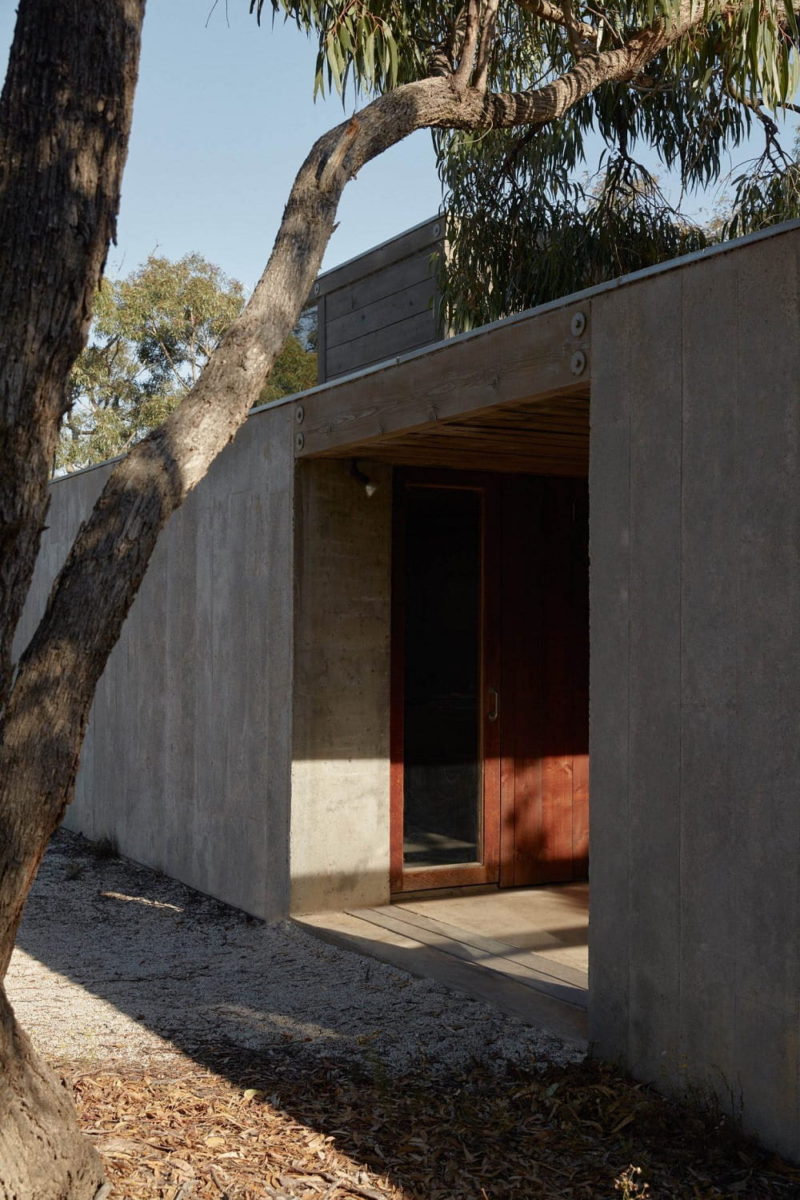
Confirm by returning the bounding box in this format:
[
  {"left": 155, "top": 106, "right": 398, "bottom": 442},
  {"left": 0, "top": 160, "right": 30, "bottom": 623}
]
[{"left": 296, "top": 300, "right": 590, "bottom": 476}]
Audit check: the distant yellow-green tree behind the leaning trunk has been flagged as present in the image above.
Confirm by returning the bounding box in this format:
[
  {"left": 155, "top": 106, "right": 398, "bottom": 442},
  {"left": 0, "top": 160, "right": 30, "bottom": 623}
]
[{"left": 55, "top": 254, "right": 317, "bottom": 472}]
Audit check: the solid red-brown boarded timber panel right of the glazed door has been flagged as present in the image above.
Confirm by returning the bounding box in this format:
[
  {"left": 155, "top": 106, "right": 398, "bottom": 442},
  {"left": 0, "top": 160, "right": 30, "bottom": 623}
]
[{"left": 500, "top": 475, "right": 589, "bottom": 887}]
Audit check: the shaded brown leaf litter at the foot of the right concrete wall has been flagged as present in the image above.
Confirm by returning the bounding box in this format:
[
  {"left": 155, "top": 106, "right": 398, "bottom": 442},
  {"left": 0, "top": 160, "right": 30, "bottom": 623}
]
[{"left": 178, "top": 1046, "right": 800, "bottom": 1200}]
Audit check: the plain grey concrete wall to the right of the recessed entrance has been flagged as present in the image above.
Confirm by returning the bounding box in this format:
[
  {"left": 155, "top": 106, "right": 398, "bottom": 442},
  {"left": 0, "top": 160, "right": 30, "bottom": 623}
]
[{"left": 590, "top": 230, "right": 800, "bottom": 1158}]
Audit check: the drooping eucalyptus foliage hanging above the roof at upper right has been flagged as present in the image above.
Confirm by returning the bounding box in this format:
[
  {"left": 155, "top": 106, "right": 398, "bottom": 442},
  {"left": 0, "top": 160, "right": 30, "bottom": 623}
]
[{"left": 260, "top": 0, "right": 800, "bottom": 329}]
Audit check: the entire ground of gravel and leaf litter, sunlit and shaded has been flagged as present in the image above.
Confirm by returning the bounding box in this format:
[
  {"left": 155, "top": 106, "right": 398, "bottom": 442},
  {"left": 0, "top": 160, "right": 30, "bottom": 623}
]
[{"left": 10, "top": 834, "right": 800, "bottom": 1200}]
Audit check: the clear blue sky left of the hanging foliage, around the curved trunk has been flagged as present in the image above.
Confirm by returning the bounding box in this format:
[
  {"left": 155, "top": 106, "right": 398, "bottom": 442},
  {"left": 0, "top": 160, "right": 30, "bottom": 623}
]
[{"left": 0, "top": 0, "right": 440, "bottom": 289}]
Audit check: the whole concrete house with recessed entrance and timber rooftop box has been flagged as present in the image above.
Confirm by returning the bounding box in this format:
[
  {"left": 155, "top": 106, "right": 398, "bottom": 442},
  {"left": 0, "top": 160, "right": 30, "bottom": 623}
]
[{"left": 30, "top": 222, "right": 800, "bottom": 1158}]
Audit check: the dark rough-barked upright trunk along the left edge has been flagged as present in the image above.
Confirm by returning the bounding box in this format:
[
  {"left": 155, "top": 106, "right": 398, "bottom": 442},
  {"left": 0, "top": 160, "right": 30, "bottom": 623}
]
[{"left": 0, "top": 0, "right": 144, "bottom": 709}]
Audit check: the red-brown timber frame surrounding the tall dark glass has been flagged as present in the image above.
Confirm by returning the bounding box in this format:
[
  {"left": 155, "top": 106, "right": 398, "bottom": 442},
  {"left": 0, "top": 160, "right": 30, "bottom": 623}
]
[{"left": 390, "top": 467, "right": 501, "bottom": 894}]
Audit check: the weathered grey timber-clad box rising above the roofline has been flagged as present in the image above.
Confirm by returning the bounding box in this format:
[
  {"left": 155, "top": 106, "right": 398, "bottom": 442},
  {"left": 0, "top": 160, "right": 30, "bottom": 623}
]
[{"left": 312, "top": 217, "right": 444, "bottom": 383}]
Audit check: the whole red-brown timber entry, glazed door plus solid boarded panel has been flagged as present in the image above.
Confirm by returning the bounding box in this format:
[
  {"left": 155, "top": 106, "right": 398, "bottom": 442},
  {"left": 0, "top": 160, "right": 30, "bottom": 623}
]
[{"left": 391, "top": 470, "right": 589, "bottom": 892}]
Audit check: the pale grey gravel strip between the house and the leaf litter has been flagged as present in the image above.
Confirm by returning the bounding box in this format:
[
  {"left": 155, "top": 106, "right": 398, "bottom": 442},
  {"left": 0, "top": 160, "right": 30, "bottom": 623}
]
[{"left": 7, "top": 830, "right": 581, "bottom": 1074}]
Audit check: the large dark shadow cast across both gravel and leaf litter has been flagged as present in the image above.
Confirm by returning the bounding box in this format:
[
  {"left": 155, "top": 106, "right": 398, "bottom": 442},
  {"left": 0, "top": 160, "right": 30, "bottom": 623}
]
[{"left": 10, "top": 833, "right": 800, "bottom": 1200}]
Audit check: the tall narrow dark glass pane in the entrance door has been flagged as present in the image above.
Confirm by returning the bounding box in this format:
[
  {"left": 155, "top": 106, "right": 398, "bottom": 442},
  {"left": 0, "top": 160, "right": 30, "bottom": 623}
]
[{"left": 403, "top": 486, "right": 483, "bottom": 869}]
